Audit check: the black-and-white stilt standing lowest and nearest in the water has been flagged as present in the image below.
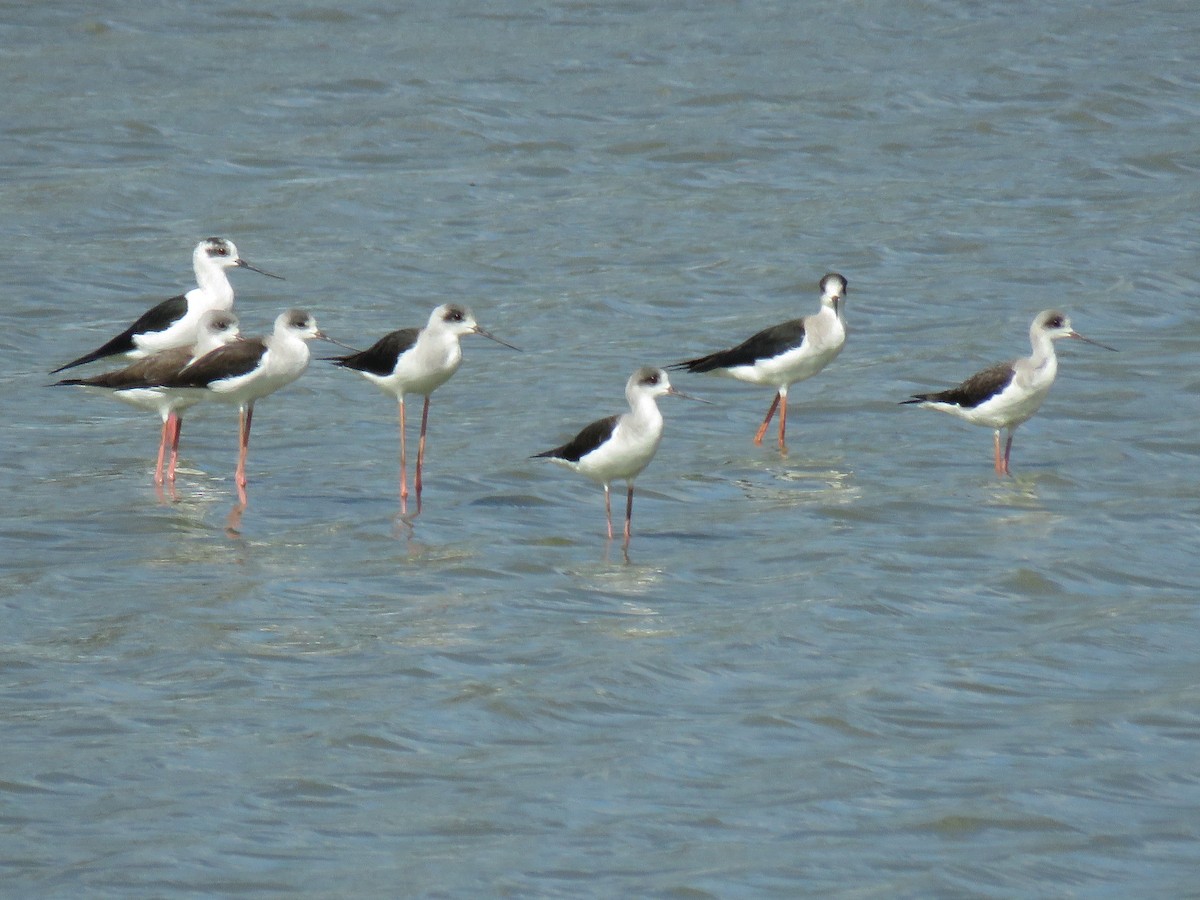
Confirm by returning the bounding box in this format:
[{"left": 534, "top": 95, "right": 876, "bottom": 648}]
[{"left": 529, "top": 366, "right": 708, "bottom": 548}]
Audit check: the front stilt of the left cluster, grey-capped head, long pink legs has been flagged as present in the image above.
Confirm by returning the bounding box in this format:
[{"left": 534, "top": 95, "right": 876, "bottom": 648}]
[{"left": 145, "top": 310, "right": 330, "bottom": 497}]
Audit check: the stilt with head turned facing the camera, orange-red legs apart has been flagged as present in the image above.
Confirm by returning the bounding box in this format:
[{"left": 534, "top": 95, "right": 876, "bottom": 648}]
[{"left": 668, "top": 272, "right": 848, "bottom": 452}]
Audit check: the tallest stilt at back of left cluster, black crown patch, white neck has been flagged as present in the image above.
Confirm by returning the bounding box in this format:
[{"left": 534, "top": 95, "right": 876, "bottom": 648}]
[{"left": 50, "top": 238, "right": 282, "bottom": 374}]
